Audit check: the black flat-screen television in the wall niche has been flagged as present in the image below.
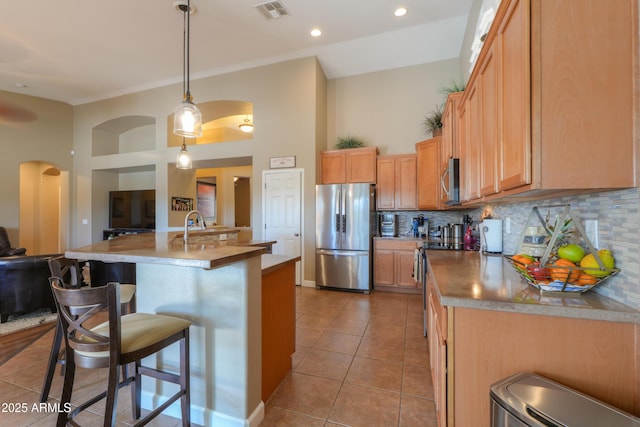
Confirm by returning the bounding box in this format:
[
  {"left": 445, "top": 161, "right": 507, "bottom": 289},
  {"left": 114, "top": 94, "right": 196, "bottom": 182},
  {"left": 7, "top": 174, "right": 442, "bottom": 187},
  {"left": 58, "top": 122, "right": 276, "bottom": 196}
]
[{"left": 109, "top": 190, "right": 156, "bottom": 229}]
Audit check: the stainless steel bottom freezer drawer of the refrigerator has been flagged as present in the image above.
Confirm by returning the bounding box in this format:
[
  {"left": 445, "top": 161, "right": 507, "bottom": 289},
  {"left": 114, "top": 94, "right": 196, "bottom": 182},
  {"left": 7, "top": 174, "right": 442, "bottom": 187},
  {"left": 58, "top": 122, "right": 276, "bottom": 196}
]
[{"left": 316, "top": 249, "right": 371, "bottom": 293}]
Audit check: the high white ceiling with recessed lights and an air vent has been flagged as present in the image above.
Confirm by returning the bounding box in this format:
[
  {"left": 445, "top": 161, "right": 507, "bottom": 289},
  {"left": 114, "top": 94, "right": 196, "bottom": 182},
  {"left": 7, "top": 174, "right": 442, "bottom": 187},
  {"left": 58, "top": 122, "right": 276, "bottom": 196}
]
[{"left": 0, "top": 0, "right": 474, "bottom": 105}]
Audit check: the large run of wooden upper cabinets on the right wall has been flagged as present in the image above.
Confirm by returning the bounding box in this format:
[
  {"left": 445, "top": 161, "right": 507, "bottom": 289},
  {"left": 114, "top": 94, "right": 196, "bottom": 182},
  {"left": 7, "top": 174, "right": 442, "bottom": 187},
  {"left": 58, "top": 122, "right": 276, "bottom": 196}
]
[{"left": 459, "top": 0, "right": 638, "bottom": 201}]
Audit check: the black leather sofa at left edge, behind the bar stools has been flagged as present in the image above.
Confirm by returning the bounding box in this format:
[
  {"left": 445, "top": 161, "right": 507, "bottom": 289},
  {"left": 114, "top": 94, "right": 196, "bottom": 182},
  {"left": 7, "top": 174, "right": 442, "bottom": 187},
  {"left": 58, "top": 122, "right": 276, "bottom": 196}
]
[{"left": 0, "top": 254, "right": 60, "bottom": 323}]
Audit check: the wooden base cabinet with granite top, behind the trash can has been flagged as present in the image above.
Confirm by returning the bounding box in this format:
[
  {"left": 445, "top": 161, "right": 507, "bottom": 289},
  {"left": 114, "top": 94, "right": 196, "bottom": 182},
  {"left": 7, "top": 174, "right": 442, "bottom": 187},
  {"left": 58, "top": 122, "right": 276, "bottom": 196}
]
[{"left": 427, "top": 250, "right": 640, "bottom": 427}]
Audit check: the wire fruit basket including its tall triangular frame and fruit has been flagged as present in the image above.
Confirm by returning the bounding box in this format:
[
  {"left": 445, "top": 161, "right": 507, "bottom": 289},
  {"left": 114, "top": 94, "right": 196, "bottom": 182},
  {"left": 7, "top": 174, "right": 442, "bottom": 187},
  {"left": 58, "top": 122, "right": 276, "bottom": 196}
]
[{"left": 504, "top": 205, "right": 620, "bottom": 293}]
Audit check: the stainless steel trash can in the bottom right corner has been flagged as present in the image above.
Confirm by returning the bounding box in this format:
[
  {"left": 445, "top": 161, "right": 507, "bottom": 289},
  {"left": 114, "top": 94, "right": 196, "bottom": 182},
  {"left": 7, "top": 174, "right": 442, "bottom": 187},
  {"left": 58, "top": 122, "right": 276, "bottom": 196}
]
[{"left": 491, "top": 372, "right": 640, "bottom": 427}]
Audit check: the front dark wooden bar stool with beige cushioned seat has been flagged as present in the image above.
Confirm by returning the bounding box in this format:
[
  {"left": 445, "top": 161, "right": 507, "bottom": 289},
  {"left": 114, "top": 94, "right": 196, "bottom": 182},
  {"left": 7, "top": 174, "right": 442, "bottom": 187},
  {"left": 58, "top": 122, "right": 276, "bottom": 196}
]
[{"left": 49, "top": 277, "right": 191, "bottom": 427}]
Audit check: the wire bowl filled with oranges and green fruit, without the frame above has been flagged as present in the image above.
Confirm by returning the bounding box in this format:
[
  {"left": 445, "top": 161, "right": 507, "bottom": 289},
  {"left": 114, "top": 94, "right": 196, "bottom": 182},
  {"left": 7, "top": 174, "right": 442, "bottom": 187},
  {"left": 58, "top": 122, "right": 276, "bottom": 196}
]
[{"left": 504, "top": 255, "right": 620, "bottom": 293}]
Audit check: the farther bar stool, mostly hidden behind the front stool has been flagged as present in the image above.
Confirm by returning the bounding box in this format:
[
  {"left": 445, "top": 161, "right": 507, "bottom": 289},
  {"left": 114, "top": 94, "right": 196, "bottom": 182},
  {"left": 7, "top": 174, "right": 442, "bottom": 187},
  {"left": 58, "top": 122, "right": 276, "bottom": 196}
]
[{"left": 40, "top": 256, "right": 136, "bottom": 403}]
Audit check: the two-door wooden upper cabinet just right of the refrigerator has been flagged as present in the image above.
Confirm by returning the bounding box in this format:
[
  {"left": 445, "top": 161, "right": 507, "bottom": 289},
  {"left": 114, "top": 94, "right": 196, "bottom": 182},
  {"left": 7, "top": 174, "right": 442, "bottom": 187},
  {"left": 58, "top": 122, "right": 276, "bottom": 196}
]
[{"left": 376, "top": 154, "right": 418, "bottom": 210}]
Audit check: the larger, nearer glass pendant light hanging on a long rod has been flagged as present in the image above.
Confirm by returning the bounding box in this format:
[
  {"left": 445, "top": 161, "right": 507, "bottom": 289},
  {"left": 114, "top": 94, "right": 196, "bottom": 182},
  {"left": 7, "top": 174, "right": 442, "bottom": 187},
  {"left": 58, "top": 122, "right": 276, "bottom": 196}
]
[{"left": 173, "top": 0, "right": 202, "bottom": 137}]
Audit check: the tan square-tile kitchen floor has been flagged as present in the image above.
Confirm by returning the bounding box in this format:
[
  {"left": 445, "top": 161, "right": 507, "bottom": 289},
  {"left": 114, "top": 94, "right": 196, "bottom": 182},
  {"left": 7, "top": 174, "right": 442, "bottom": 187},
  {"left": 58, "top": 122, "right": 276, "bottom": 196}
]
[{"left": 0, "top": 287, "right": 437, "bottom": 427}]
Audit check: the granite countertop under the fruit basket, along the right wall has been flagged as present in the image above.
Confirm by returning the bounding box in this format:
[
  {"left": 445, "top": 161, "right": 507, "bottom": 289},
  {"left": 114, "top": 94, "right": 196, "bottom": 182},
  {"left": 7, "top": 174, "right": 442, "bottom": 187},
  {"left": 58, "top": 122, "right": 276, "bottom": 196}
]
[{"left": 427, "top": 250, "right": 640, "bottom": 323}]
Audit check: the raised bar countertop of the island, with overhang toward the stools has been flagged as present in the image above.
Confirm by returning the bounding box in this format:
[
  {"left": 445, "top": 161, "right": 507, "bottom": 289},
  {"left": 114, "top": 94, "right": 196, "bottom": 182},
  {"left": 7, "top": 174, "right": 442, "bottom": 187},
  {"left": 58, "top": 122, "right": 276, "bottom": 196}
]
[{"left": 65, "top": 231, "right": 268, "bottom": 269}]
